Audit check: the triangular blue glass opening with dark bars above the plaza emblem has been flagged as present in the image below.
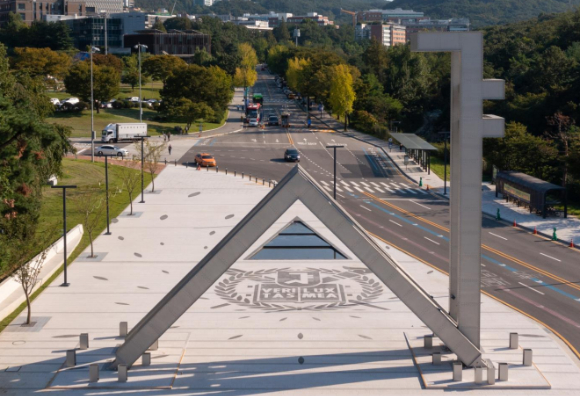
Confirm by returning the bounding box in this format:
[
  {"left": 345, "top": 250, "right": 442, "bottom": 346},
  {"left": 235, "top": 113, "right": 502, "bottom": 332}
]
[{"left": 250, "top": 221, "right": 346, "bottom": 260}]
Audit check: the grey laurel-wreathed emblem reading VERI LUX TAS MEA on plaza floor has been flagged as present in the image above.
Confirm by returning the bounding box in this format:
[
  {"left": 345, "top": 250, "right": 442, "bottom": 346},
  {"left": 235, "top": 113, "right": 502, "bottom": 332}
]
[{"left": 215, "top": 267, "right": 383, "bottom": 310}]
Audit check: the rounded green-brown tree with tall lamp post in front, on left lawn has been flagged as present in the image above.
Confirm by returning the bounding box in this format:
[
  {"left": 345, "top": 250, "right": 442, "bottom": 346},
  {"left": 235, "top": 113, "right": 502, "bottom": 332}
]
[{"left": 64, "top": 61, "right": 120, "bottom": 113}]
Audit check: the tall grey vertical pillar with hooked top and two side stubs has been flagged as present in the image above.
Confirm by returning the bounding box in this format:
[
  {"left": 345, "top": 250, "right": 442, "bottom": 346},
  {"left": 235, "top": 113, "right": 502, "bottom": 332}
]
[{"left": 411, "top": 32, "right": 504, "bottom": 348}]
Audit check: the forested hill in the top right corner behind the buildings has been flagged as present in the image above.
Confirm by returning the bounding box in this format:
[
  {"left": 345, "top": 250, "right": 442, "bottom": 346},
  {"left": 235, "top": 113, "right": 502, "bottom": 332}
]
[{"left": 382, "top": 0, "right": 580, "bottom": 28}]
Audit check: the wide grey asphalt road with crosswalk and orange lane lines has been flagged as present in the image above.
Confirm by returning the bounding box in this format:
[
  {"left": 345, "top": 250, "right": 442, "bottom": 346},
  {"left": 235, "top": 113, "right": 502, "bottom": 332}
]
[{"left": 181, "top": 73, "right": 580, "bottom": 358}]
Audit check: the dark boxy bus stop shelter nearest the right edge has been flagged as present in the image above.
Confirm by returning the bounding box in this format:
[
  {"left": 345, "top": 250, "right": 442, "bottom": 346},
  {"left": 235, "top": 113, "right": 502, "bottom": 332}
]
[{"left": 495, "top": 171, "right": 568, "bottom": 219}]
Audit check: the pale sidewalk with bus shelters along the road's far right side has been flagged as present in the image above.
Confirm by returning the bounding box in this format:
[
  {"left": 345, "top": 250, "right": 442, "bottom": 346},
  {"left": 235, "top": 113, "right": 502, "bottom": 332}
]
[{"left": 311, "top": 113, "right": 580, "bottom": 244}]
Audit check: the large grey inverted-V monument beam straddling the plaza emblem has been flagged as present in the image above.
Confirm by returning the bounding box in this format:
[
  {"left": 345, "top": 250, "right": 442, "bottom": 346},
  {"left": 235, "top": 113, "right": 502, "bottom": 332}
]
[{"left": 112, "top": 165, "right": 483, "bottom": 368}]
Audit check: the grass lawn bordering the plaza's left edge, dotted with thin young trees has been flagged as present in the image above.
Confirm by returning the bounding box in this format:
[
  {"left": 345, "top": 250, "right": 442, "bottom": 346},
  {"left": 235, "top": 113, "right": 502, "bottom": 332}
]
[{"left": 0, "top": 158, "right": 151, "bottom": 331}]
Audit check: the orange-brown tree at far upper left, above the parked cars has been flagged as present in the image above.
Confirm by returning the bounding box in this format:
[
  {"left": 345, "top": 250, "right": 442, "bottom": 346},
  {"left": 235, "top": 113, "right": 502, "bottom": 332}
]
[{"left": 12, "top": 48, "right": 71, "bottom": 79}]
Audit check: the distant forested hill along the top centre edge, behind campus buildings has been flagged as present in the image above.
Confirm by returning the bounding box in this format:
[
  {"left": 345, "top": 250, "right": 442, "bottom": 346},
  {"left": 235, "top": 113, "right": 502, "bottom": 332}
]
[{"left": 135, "top": 0, "right": 386, "bottom": 21}]
